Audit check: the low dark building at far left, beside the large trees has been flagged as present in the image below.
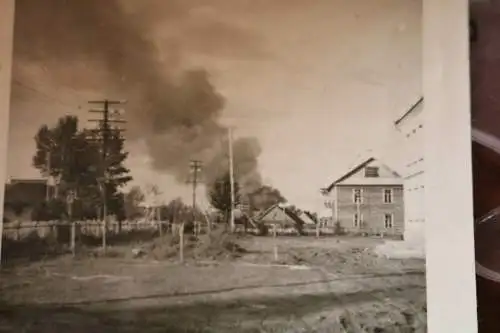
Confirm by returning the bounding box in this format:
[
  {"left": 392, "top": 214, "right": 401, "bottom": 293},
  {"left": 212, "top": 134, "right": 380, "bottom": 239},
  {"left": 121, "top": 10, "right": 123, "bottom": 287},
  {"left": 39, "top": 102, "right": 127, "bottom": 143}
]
[{"left": 3, "top": 179, "right": 51, "bottom": 222}]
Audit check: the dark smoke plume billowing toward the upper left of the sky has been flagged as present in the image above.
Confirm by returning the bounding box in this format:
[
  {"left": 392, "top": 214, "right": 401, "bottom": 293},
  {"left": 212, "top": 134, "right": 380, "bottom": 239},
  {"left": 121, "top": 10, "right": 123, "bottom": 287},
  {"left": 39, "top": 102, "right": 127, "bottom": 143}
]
[{"left": 13, "top": 0, "right": 266, "bottom": 191}]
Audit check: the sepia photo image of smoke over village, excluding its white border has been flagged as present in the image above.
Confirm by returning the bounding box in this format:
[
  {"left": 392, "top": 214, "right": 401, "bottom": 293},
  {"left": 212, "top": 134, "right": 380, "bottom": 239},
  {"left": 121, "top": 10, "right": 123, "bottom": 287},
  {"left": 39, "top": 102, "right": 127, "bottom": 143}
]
[{"left": 0, "top": 0, "right": 426, "bottom": 333}]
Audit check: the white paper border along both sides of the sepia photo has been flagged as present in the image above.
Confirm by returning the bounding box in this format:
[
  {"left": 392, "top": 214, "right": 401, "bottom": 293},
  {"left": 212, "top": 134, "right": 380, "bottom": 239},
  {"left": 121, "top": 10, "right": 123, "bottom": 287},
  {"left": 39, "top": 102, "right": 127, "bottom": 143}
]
[{"left": 0, "top": 0, "right": 477, "bottom": 333}]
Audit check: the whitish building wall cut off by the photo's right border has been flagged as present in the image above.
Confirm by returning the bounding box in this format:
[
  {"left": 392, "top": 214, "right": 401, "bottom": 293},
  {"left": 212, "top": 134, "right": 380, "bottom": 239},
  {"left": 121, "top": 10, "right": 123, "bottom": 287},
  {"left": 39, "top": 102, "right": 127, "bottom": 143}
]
[{"left": 397, "top": 102, "right": 425, "bottom": 246}]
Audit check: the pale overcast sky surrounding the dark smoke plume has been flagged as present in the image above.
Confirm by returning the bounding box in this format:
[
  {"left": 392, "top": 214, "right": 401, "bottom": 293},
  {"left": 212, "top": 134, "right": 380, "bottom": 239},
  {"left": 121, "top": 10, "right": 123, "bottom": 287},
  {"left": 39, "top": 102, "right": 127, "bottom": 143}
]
[{"left": 8, "top": 0, "right": 421, "bottom": 210}]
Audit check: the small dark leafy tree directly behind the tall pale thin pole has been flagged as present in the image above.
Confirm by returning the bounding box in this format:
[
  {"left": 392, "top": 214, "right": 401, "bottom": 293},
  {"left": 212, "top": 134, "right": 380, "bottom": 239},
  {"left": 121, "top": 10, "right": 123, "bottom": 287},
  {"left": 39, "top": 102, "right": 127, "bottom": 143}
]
[{"left": 209, "top": 173, "right": 240, "bottom": 222}]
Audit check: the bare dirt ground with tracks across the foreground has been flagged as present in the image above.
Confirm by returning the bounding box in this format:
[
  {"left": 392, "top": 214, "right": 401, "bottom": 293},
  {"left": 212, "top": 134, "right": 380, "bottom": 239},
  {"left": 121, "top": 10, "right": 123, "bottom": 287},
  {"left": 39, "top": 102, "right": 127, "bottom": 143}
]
[{"left": 0, "top": 237, "right": 426, "bottom": 333}]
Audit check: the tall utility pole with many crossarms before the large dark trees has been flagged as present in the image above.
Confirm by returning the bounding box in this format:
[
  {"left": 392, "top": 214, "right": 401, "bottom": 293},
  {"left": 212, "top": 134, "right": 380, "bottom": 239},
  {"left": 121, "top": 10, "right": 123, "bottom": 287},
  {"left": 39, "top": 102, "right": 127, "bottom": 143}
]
[{"left": 88, "top": 99, "right": 126, "bottom": 251}]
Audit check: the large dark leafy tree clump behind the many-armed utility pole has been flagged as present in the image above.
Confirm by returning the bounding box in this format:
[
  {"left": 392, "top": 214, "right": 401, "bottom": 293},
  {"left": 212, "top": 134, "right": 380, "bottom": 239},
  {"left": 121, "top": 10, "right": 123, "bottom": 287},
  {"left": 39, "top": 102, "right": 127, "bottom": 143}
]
[{"left": 33, "top": 116, "right": 132, "bottom": 219}]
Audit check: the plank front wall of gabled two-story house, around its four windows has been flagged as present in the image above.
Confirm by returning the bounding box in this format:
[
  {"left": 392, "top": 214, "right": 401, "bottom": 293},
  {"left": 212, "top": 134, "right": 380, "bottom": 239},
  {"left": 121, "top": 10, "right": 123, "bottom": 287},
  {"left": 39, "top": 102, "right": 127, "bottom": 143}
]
[{"left": 336, "top": 185, "right": 404, "bottom": 236}]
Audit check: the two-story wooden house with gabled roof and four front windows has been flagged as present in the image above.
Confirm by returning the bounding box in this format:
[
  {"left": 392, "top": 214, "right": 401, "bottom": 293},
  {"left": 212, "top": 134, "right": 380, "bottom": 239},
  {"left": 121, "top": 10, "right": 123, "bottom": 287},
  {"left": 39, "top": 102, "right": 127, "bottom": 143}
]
[{"left": 322, "top": 157, "right": 404, "bottom": 237}]
